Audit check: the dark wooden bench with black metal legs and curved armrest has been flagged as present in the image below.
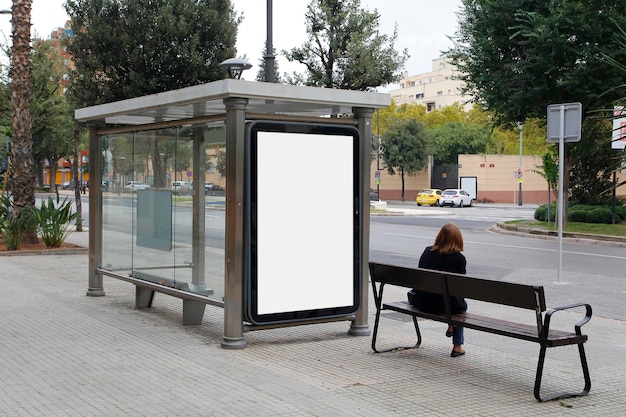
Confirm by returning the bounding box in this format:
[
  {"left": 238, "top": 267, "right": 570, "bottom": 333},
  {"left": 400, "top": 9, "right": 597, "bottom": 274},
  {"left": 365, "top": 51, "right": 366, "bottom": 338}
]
[{"left": 369, "top": 262, "right": 591, "bottom": 401}]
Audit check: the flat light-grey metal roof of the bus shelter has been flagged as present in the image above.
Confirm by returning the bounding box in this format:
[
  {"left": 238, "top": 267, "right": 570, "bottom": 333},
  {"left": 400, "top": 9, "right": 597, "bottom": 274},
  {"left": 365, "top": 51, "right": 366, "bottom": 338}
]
[{"left": 75, "top": 79, "right": 391, "bottom": 125}]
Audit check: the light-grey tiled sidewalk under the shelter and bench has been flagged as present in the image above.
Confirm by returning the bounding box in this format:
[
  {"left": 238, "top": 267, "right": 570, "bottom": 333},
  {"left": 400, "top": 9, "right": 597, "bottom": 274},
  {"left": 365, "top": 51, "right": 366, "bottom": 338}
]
[{"left": 0, "top": 226, "right": 626, "bottom": 417}]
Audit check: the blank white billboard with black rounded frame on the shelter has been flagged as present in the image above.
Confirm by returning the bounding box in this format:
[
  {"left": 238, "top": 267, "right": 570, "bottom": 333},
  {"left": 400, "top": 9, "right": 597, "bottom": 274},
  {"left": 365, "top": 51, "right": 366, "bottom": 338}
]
[{"left": 248, "top": 122, "right": 360, "bottom": 322}]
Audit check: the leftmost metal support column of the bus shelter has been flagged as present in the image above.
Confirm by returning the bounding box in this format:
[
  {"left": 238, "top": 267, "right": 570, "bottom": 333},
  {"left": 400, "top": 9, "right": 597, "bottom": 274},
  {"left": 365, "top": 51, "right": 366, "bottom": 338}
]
[{"left": 87, "top": 123, "right": 104, "bottom": 297}]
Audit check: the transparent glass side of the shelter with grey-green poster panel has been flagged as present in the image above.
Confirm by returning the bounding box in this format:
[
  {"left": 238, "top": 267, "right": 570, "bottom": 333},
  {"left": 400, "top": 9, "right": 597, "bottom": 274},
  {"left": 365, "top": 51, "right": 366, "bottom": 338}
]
[{"left": 100, "top": 124, "right": 226, "bottom": 300}]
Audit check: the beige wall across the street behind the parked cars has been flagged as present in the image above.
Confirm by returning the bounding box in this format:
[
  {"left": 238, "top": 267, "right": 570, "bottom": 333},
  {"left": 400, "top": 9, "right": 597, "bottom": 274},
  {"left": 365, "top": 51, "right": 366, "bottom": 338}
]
[{"left": 371, "top": 155, "right": 626, "bottom": 204}]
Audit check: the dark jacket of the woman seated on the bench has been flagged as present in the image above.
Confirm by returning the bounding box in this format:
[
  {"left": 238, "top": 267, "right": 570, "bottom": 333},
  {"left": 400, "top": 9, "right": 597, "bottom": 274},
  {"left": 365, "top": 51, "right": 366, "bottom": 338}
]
[{"left": 409, "top": 246, "right": 467, "bottom": 314}]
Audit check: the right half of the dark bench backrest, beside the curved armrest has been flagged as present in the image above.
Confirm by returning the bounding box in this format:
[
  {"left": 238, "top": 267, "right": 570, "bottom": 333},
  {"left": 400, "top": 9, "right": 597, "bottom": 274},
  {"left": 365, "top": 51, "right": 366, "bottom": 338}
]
[{"left": 446, "top": 274, "right": 546, "bottom": 311}]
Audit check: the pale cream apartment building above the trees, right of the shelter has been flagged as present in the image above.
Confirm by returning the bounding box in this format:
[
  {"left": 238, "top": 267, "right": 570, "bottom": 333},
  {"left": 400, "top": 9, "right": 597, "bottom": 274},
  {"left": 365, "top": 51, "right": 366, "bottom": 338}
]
[{"left": 389, "top": 57, "right": 471, "bottom": 112}]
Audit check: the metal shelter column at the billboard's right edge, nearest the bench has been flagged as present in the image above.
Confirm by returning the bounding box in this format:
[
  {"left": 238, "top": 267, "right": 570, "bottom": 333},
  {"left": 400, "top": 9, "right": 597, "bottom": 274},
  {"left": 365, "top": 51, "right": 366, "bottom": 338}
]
[{"left": 348, "top": 107, "right": 374, "bottom": 336}]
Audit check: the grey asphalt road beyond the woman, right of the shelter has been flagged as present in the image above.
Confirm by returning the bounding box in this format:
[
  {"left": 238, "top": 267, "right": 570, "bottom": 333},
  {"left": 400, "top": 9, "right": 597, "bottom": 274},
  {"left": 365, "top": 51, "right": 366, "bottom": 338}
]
[{"left": 370, "top": 203, "right": 626, "bottom": 319}]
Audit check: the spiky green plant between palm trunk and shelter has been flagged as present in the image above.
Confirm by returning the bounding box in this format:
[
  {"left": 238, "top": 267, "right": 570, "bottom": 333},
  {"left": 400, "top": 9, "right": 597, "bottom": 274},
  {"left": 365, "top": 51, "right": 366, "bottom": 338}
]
[{"left": 31, "top": 193, "right": 78, "bottom": 248}]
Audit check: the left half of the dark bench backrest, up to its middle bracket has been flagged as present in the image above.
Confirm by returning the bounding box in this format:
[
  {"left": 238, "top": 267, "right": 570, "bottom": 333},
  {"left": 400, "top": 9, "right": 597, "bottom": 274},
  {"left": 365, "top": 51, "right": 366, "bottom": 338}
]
[{"left": 370, "top": 262, "right": 445, "bottom": 294}]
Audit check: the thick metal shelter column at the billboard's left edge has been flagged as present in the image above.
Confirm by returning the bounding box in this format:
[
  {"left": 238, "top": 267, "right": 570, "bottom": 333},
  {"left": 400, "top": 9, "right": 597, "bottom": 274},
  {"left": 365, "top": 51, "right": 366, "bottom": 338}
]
[{"left": 221, "top": 97, "right": 248, "bottom": 349}]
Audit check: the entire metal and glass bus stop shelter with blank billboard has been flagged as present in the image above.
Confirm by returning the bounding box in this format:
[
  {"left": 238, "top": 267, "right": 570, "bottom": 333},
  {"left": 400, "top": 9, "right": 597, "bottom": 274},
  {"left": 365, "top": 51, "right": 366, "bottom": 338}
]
[{"left": 75, "top": 79, "right": 390, "bottom": 349}]
